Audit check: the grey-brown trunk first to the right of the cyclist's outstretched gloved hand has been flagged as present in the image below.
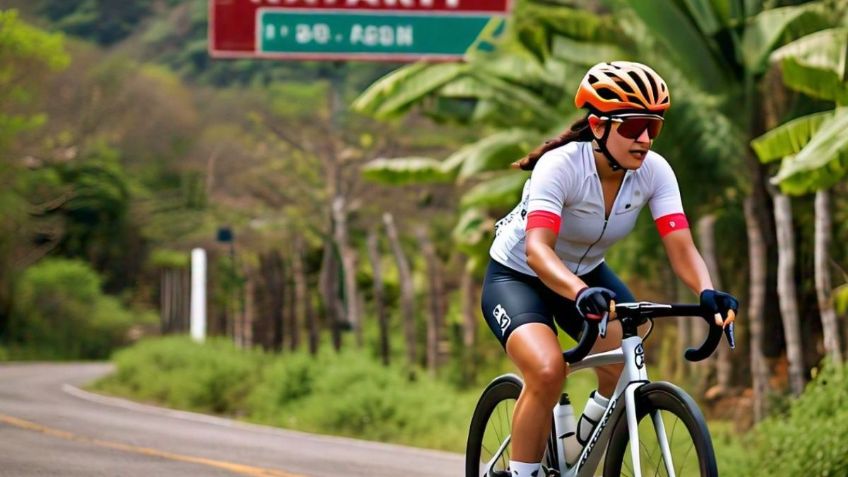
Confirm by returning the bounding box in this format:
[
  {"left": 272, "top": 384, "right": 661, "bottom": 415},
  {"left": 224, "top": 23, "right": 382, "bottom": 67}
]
[{"left": 745, "top": 197, "right": 769, "bottom": 422}]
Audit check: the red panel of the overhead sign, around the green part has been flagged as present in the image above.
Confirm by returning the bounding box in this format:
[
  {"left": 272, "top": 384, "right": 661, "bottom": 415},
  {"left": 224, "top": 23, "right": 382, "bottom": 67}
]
[{"left": 209, "top": 0, "right": 511, "bottom": 58}]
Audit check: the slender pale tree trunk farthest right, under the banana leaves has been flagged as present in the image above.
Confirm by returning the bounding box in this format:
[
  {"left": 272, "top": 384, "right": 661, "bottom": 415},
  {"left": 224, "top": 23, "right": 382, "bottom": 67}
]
[{"left": 815, "top": 189, "right": 842, "bottom": 363}]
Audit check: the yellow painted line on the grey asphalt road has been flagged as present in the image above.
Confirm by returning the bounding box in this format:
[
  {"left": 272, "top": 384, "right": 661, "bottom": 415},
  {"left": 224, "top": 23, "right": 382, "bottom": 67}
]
[{"left": 0, "top": 414, "right": 304, "bottom": 477}]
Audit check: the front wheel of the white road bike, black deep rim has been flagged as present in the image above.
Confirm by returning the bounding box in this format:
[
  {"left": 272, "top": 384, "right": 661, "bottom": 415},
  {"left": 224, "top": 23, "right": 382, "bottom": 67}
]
[{"left": 604, "top": 382, "right": 718, "bottom": 477}]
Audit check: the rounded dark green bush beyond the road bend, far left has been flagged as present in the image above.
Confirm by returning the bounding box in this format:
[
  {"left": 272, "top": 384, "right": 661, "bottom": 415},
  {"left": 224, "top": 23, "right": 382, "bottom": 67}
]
[{"left": 5, "top": 258, "right": 155, "bottom": 359}]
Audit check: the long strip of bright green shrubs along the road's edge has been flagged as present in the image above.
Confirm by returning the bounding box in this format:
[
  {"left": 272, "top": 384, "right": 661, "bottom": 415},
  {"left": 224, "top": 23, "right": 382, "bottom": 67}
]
[{"left": 94, "top": 337, "right": 480, "bottom": 452}]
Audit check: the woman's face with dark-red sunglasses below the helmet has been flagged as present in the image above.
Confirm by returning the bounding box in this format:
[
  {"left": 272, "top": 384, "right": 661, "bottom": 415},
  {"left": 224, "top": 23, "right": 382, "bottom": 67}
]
[{"left": 592, "top": 118, "right": 661, "bottom": 170}]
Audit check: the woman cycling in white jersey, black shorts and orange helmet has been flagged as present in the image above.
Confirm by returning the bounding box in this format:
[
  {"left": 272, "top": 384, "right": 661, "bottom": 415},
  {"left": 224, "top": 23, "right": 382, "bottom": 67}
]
[{"left": 482, "top": 61, "right": 738, "bottom": 477}]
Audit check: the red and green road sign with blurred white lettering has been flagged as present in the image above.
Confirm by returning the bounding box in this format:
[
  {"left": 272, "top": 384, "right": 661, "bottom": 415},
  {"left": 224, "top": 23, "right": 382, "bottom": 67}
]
[{"left": 209, "top": 0, "right": 511, "bottom": 61}]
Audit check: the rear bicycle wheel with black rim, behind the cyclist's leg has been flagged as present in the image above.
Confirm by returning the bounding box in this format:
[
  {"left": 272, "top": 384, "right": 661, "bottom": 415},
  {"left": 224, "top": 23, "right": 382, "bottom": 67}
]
[{"left": 465, "top": 374, "right": 556, "bottom": 477}]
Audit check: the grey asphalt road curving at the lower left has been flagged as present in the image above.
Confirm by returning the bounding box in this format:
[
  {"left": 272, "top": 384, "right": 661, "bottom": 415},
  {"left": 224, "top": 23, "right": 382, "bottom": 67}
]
[{"left": 0, "top": 363, "right": 463, "bottom": 477}]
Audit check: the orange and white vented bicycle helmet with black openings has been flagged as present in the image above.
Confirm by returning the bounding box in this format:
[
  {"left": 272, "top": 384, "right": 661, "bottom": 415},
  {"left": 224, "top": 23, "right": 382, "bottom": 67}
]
[{"left": 574, "top": 61, "right": 671, "bottom": 115}]
